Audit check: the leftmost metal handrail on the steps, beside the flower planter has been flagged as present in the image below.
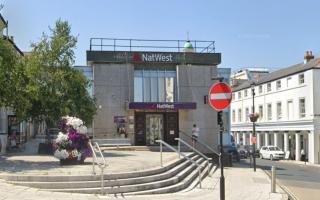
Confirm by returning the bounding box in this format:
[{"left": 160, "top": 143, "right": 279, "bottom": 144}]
[{"left": 89, "top": 141, "right": 107, "bottom": 195}]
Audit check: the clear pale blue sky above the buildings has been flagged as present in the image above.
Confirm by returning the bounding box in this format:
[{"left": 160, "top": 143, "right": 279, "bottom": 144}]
[{"left": 0, "top": 0, "right": 320, "bottom": 71}]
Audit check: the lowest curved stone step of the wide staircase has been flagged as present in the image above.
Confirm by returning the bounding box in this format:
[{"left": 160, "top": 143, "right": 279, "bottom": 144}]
[{"left": 38, "top": 158, "right": 204, "bottom": 194}]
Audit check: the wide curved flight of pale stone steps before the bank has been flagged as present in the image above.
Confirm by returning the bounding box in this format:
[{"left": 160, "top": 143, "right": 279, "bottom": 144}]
[{"left": 0, "top": 141, "right": 216, "bottom": 195}]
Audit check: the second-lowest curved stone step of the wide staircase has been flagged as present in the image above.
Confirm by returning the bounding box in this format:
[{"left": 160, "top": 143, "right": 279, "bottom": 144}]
[{"left": 8, "top": 156, "right": 200, "bottom": 189}]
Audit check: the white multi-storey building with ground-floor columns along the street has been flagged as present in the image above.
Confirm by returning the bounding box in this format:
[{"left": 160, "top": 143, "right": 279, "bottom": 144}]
[{"left": 231, "top": 52, "right": 320, "bottom": 163}]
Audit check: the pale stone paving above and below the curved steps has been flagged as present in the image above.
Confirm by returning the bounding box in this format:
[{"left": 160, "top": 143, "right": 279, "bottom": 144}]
[{"left": 0, "top": 140, "right": 288, "bottom": 200}]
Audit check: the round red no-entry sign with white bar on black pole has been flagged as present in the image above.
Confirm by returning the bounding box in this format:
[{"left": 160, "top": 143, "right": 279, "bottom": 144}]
[{"left": 208, "top": 82, "right": 232, "bottom": 110}]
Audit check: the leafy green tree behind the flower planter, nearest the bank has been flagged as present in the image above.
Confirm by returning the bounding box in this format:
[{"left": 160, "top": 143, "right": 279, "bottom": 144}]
[{"left": 26, "top": 20, "right": 96, "bottom": 127}]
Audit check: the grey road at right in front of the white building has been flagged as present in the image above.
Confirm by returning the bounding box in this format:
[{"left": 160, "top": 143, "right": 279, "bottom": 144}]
[{"left": 241, "top": 158, "right": 320, "bottom": 200}]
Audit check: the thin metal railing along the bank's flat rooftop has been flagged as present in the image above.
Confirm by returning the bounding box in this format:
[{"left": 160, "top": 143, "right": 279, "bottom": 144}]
[{"left": 90, "top": 38, "right": 215, "bottom": 53}]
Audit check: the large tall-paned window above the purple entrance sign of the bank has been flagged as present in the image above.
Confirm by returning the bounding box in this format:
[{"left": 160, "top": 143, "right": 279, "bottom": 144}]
[{"left": 134, "top": 69, "right": 176, "bottom": 102}]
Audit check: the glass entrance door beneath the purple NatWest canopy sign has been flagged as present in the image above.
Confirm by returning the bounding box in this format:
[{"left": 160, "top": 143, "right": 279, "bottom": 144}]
[{"left": 146, "top": 114, "right": 163, "bottom": 145}]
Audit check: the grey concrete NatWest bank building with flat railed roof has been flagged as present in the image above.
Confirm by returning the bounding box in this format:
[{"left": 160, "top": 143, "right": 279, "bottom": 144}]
[{"left": 87, "top": 38, "right": 221, "bottom": 146}]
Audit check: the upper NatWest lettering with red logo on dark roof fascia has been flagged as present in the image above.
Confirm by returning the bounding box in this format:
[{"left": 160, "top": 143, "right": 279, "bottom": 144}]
[{"left": 133, "top": 53, "right": 173, "bottom": 62}]
